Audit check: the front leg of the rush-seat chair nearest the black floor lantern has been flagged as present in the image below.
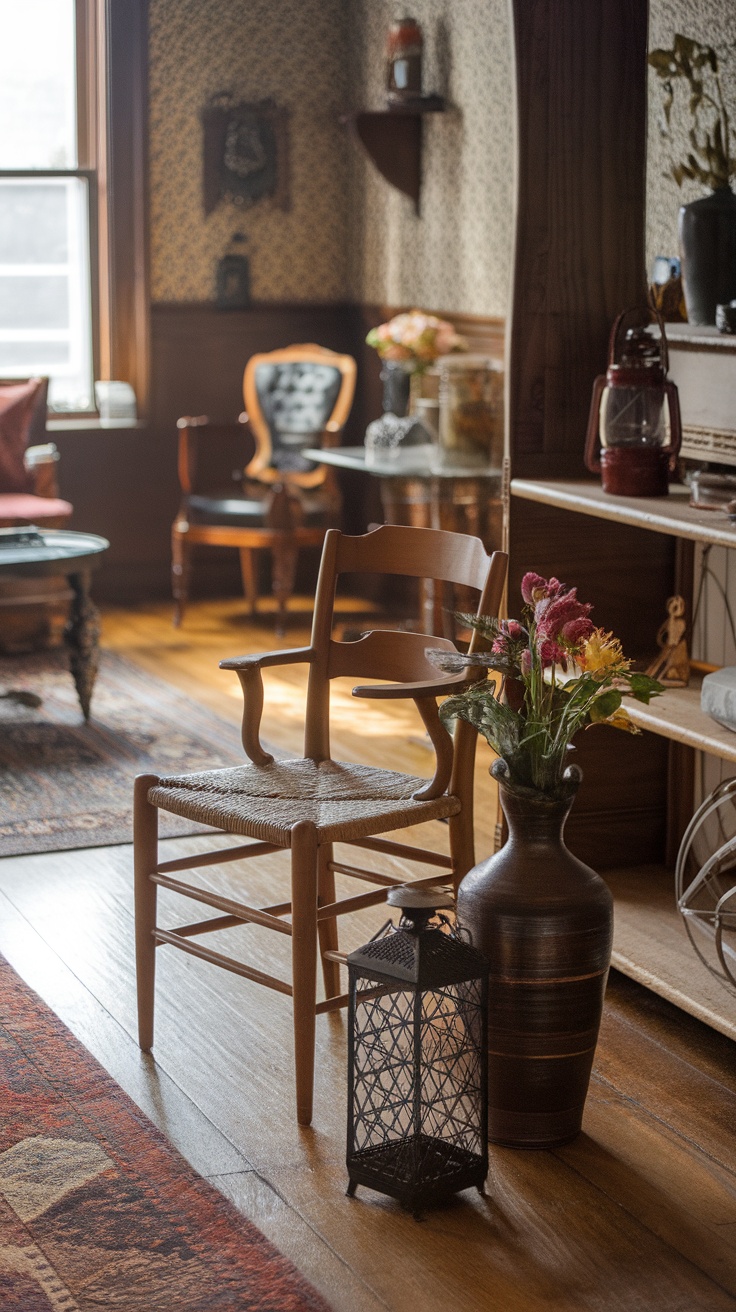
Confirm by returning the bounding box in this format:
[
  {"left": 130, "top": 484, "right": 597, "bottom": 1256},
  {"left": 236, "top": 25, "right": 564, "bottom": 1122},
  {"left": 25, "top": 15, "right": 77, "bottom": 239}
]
[{"left": 291, "top": 820, "right": 319, "bottom": 1126}]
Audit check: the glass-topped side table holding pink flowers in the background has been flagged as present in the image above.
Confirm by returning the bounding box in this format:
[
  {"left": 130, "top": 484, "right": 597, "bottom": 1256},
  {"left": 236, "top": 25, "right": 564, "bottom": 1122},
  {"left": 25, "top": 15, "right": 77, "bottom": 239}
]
[{"left": 303, "top": 446, "right": 502, "bottom": 638}]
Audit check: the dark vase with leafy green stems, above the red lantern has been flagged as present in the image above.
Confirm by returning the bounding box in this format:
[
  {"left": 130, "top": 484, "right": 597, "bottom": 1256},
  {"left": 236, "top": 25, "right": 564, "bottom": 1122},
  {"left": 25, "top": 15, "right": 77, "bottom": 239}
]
[{"left": 680, "top": 186, "right": 736, "bottom": 325}]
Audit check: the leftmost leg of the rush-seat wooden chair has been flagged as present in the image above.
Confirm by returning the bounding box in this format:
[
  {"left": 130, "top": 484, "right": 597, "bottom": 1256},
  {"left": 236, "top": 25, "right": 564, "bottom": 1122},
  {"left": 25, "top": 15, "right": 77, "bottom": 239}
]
[{"left": 133, "top": 774, "right": 159, "bottom": 1052}]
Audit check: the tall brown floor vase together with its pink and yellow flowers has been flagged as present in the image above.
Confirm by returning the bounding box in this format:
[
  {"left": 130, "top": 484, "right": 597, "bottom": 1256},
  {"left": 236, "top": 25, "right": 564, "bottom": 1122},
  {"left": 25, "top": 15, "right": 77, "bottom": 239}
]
[{"left": 433, "top": 573, "right": 663, "bottom": 1148}]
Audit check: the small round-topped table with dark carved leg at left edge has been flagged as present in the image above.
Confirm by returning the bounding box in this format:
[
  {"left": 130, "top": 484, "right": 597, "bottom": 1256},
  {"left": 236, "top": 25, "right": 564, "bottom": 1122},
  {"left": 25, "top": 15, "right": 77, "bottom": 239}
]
[{"left": 0, "top": 529, "right": 110, "bottom": 720}]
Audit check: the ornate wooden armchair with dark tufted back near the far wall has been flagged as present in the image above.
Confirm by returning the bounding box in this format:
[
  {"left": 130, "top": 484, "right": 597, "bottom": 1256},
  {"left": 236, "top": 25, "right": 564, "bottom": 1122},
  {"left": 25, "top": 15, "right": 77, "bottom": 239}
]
[{"left": 172, "top": 344, "right": 356, "bottom": 634}]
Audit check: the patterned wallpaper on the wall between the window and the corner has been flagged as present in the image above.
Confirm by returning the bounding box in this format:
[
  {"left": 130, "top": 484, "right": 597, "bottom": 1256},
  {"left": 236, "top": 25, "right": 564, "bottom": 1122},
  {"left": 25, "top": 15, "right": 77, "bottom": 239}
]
[{"left": 150, "top": 0, "right": 350, "bottom": 302}]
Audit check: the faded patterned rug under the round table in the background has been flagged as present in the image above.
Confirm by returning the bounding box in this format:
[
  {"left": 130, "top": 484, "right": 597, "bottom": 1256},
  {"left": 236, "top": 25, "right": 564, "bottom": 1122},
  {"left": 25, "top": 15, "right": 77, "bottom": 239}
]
[{"left": 0, "top": 651, "right": 245, "bottom": 857}]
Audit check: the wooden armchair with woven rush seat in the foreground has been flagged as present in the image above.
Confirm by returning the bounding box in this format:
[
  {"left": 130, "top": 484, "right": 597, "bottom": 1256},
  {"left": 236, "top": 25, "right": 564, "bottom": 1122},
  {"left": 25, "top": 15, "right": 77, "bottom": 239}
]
[{"left": 135, "top": 525, "right": 506, "bottom": 1126}]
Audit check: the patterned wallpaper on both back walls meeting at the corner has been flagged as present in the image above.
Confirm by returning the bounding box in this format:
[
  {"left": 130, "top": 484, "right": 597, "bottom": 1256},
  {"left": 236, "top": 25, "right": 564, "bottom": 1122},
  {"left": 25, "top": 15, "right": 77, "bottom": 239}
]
[{"left": 144, "top": 0, "right": 513, "bottom": 315}]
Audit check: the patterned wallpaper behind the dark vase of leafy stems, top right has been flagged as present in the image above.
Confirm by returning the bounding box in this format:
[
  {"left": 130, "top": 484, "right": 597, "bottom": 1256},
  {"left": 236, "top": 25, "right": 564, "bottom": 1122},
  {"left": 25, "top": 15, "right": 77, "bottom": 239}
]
[{"left": 647, "top": 0, "right": 736, "bottom": 270}]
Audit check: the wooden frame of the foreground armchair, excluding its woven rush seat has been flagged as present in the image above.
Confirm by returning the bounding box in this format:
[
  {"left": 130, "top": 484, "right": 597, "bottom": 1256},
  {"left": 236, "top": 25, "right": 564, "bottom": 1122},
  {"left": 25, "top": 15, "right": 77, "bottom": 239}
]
[{"left": 134, "top": 525, "right": 506, "bottom": 1126}]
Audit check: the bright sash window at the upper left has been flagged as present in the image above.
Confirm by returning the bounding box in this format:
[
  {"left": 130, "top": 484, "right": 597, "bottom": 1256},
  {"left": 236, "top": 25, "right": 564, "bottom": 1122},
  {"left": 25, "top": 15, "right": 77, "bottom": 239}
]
[{"left": 0, "top": 0, "right": 97, "bottom": 412}]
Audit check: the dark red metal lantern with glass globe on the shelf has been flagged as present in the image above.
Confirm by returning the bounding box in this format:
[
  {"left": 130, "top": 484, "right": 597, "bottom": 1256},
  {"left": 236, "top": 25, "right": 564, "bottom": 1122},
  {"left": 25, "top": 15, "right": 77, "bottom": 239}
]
[{"left": 585, "top": 310, "right": 682, "bottom": 496}]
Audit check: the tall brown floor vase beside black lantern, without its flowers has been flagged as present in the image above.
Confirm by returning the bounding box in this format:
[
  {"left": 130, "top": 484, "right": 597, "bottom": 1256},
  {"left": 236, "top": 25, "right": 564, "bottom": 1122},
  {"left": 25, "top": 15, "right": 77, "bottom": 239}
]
[{"left": 458, "top": 761, "right": 613, "bottom": 1148}]
